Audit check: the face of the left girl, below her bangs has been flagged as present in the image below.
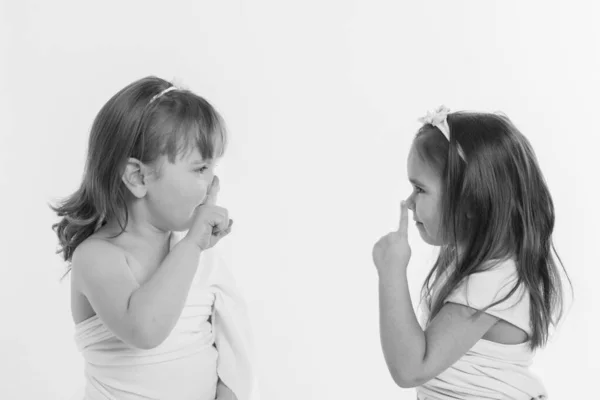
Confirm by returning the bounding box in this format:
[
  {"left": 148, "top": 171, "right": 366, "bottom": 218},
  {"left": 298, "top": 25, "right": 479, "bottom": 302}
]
[{"left": 146, "top": 149, "right": 220, "bottom": 231}]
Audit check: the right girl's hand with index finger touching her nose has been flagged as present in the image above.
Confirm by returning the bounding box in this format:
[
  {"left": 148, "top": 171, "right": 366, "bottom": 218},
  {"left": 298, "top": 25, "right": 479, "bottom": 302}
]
[{"left": 373, "top": 201, "right": 411, "bottom": 277}]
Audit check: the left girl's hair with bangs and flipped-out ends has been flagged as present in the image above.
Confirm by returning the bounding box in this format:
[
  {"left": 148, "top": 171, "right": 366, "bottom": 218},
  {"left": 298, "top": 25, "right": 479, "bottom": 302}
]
[{"left": 51, "top": 76, "right": 227, "bottom": 278}]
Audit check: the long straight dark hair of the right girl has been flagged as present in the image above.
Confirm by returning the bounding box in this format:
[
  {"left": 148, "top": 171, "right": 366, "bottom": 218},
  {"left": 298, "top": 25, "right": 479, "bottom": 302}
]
[{"left": 414, "top": 112, "right": 570, "bottom": 349}]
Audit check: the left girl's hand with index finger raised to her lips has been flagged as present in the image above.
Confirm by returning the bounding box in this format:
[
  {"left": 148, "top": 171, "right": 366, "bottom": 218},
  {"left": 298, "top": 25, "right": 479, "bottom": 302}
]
[{"left": 186, "top": 176, "right": 233, "bottom": 250}]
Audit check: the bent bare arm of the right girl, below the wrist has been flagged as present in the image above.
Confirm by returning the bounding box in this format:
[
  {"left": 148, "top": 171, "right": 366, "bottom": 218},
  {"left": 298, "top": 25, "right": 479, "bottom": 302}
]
[{"left": 379, "top": 271, "right": 498, "bottom": 388}]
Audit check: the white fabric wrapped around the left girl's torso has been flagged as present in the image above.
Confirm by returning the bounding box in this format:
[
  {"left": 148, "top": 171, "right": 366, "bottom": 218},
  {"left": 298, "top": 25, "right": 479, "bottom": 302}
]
[{"left": 75, "top": 233, "right": 254, "bottom": 400}]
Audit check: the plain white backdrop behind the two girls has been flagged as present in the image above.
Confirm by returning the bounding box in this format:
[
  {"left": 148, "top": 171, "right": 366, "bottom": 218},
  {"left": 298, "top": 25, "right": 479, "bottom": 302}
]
[{"left": 0, "top": 0, "right": 600, "bottom": 400}]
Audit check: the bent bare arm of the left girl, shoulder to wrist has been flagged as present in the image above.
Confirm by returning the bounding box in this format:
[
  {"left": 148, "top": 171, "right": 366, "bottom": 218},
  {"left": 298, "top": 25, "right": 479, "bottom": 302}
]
[{"left": 72, "top": 238, "right": 201, "bottom": 349}]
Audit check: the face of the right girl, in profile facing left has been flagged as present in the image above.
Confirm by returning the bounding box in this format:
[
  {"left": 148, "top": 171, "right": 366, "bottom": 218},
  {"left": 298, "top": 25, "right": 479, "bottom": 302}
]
[{"left": 407, "top": 145, "right": 443, "bottom": 246}]
